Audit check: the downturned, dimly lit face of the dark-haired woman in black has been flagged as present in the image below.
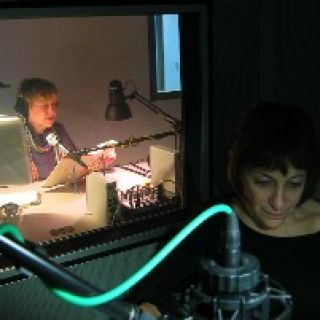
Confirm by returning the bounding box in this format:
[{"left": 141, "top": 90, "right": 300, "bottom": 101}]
[{"left": 244, "top": 166, "right": 307, "bottom": 229}]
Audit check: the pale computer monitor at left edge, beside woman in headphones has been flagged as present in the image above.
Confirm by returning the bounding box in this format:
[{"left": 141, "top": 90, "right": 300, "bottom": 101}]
[{"left": 0, "top": 115, "right": 32, "bottom": 186}]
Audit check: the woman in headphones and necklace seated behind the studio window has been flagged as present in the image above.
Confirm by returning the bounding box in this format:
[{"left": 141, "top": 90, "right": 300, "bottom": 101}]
[{"left": 14, "top": 78, "right": 116, "bottom": 181}]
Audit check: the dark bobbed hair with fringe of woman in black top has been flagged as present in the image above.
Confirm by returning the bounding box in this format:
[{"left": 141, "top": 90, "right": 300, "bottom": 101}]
[{"left": 228, "top": 102, "right": 319, "bottom": 203}]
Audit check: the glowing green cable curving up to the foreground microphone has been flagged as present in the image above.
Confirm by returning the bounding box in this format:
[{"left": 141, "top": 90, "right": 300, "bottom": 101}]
[{"left": 0, "top": 204, "right": 233, "bottom": 307}]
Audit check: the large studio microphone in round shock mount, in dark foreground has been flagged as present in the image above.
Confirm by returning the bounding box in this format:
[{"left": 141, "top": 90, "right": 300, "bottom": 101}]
[{"left": 178, "top": 213, "right": 292, "bottom": 320}]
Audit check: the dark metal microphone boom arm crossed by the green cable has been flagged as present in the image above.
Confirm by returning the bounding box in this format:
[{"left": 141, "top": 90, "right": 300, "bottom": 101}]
[{"left": 0, "top": 235, "right": 160, "bottom": 320}]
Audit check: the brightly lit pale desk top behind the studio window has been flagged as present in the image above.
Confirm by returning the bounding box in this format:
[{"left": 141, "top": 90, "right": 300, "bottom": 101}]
[{"left": 0, "top": 163, "right": 148, "bottom": 242}]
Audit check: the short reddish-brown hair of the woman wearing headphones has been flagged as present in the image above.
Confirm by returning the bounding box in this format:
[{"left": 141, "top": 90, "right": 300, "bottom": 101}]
[{"left": 14, "top": 78, "right": 58, "bottom": 118}]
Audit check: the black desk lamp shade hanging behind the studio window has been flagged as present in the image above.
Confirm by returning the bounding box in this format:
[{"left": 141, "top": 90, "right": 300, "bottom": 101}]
[{"left": 105, "top": 80, "right": 132, "bottom": 121}]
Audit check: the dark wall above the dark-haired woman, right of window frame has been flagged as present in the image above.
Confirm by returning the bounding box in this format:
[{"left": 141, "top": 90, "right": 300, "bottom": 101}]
[{"left": 212, "top": 0, "right": 320, "bottom": 193}]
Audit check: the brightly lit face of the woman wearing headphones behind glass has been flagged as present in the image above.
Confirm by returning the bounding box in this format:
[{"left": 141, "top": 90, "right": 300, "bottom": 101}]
[{"left": 28, "top": 94, "right": 58, "bottom": 133}]
